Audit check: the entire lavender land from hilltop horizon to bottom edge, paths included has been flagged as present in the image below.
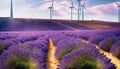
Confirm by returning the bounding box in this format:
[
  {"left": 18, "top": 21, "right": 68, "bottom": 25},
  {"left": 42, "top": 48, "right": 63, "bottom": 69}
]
[{"left": 0, "top": 18, "right": 120, "bottom": 69}]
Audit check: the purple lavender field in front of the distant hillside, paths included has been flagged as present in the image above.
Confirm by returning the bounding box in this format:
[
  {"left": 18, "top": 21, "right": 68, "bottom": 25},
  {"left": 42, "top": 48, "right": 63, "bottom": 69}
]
[{"left": 0, "top": 30, "right": 120, "bottom": 69}]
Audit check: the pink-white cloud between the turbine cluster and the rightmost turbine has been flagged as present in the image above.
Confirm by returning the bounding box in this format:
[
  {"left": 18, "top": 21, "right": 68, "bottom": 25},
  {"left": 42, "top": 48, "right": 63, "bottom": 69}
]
[{"left": 87, "top": 3, "right": 118, "bottom": 15}]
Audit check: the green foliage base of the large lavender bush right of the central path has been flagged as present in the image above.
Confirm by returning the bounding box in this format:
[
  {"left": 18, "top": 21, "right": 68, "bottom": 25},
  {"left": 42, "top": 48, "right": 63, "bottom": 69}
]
[{"left": 67, "top": 58, "right": 102, "bottom": 69}]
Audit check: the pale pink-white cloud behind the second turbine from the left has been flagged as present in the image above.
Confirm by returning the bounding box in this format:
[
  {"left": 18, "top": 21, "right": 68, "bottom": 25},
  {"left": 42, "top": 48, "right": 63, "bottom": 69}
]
[{"left": 37, "top": 0, "right": 70, "bottom": 16}]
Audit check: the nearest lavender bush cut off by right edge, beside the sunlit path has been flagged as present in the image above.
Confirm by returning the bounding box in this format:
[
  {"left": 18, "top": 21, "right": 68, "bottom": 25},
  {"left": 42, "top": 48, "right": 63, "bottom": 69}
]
[{"left": 110, "top": 40, "right": 120, "bottom": 59}]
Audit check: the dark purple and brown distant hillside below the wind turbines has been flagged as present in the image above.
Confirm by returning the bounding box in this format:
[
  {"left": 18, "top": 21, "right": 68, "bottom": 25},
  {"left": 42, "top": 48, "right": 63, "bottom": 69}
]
[{"left": 0, "top": 18, "right": 120, "bottom": 31}]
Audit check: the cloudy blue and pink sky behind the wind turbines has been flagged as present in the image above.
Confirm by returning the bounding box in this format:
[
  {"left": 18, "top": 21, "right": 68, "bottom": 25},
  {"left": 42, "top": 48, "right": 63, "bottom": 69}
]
[{"left": 0, "top": 0, "right": 120, "bottom": 22}]
